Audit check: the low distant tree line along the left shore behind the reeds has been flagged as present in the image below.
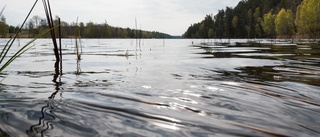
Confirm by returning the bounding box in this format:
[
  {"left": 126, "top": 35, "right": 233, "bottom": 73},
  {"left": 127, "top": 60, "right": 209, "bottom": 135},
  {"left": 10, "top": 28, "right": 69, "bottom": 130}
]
[{"left": 0, "top": 15, "right": 172, "bottom": 38}]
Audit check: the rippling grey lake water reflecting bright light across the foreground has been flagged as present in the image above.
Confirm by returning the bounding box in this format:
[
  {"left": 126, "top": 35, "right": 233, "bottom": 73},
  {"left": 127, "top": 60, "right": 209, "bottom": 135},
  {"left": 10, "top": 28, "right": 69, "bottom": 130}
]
[{"left": 0, "top": 39, "right": 320, "bottom": 137}]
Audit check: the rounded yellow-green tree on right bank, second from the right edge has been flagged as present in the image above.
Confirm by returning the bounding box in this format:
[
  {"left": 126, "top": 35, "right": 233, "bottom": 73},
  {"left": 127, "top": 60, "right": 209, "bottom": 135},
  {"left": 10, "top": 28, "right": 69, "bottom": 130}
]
[{"left": 275, "top": 9, "right": 294, "bottom": 36}]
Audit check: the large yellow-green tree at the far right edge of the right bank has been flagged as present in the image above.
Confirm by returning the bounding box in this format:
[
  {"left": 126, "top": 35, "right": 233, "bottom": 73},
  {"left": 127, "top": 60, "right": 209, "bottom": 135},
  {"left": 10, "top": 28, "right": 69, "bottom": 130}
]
[{"left": 295, "top": 0, "right": 320, "bottom": 38}]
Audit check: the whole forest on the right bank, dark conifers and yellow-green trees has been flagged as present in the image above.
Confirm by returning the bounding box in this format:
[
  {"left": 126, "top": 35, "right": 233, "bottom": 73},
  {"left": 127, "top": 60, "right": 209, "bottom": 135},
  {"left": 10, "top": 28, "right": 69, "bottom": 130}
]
[{"left": 183, "top": 0, "right": 320, "bottom": 39}]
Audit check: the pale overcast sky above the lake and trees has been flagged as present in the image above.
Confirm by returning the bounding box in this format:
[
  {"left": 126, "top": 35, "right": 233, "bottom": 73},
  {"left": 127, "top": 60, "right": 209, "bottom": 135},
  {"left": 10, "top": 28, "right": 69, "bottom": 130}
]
[{"left": 0, "top": 0, "right": 240, "bottom": 36}]
